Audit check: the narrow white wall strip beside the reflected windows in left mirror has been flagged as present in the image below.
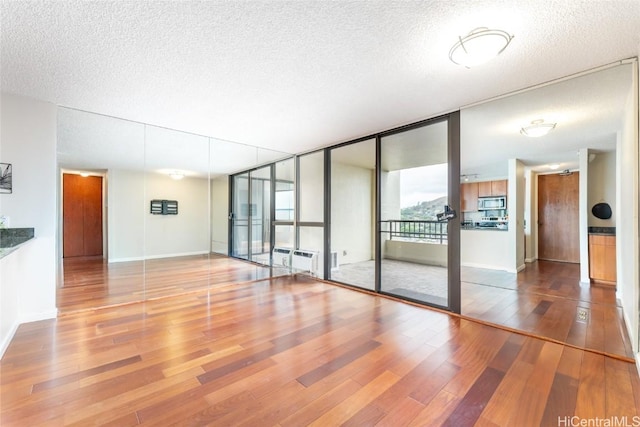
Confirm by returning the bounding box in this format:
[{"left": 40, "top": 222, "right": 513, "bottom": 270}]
[{"left": 211, "top": 176, "right": 229, "bottom": 255}]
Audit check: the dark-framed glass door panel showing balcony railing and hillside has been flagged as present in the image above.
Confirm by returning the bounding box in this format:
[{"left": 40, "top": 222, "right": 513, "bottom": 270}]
[{"left": 378, "top": 118, "right": 460, "bottom": 311}]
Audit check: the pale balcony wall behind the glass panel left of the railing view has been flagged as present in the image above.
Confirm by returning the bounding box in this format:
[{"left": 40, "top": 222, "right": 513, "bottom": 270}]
[{"left": 331, "top": 162, "right": 375, "bottom": 265}]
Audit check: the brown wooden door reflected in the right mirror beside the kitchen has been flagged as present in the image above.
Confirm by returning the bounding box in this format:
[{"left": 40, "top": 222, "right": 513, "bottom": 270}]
[{"left": 538, "top": 172, "right": 580, "bottom": 263}]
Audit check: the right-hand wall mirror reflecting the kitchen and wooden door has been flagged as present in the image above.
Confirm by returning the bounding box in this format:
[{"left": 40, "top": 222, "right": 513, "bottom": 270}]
[{"left": 460, "top": 64, "right": 633, "bottom": 357}]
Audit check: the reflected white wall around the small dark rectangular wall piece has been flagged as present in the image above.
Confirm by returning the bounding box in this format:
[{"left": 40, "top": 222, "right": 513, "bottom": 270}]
[{"left": 107, "top": 170, "right": 210, "bottom": 262}]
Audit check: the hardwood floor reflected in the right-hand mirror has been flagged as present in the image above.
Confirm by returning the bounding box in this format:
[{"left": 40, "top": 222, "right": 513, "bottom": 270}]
[{"left": 462, "top": 261, "right": 633, "bottom": 361}]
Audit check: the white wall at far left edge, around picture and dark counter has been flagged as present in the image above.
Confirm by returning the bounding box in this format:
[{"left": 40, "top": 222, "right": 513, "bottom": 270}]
[{"left": 0, "top": 93, "right": 57, "bottom": 358}]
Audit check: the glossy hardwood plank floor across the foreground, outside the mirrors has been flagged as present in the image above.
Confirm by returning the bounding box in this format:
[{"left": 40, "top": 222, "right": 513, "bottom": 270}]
[{"left": 0, "top": 275, "right": 640, "bottom": 427}]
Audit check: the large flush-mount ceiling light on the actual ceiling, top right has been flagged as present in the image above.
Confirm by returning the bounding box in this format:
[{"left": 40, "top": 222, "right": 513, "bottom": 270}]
[{"left": 449, "top": 27, "right": 513, "bottom": 68}]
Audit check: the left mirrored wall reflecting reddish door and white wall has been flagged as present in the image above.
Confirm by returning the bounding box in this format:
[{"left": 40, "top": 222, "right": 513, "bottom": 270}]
[{"left": 57, "top": 108, "right": 293, "bottom": 312}]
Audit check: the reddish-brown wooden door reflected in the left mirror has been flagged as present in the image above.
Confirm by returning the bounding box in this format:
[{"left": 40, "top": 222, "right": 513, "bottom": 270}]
[{"left": 62, "top": 174, "right": 102, "bottom": 258}]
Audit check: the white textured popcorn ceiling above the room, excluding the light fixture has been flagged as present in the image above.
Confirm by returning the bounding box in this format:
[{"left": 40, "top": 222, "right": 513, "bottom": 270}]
[{"left": 1, "top": 0, "right": 640, "bottom": 153}]
